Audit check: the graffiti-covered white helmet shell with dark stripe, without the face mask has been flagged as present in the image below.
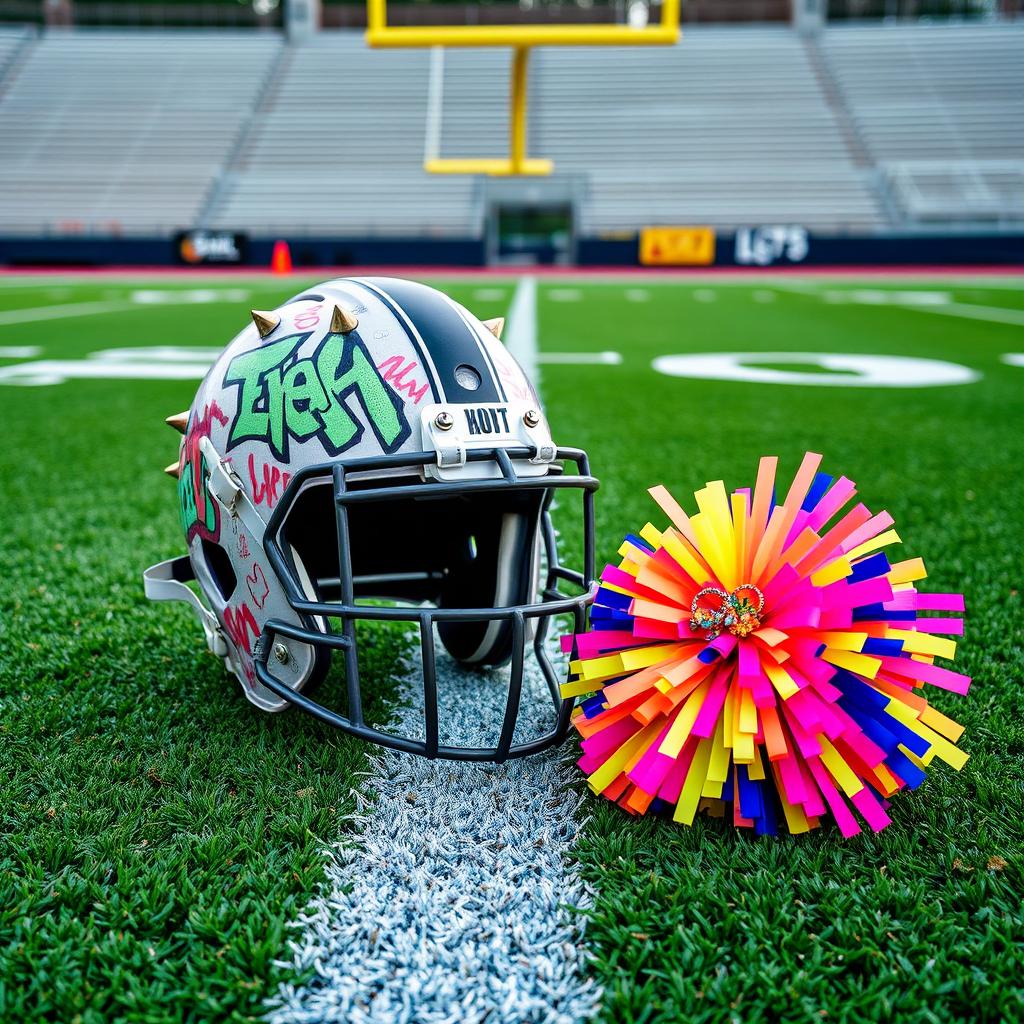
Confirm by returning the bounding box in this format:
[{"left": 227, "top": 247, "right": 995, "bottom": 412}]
[{"left": 178, "top": 278, "right": 547, "bottom": 711}]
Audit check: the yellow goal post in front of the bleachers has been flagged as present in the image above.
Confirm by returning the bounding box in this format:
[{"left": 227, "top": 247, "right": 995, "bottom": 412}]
[{"left": 366, "top": 0, "right": 680, "bottom": 177}]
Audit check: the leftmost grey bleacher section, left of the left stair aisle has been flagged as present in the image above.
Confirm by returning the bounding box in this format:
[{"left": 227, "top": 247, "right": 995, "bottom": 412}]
[{"left": 0, "top": 32, "right": 282, "bottom": 234}]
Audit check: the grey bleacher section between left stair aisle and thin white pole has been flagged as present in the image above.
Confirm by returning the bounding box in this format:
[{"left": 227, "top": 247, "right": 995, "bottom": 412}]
[{"left": 213, "top": 33, "right": 481, "bottom": 237}]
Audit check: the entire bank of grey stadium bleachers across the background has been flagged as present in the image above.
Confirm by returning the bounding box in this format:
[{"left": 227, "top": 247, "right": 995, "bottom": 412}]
[{"left": 0, "top": 24, "right": 1024, "bottom": 238}]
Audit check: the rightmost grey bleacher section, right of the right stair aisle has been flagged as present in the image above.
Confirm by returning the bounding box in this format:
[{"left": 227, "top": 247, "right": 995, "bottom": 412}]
[{"left": 822, "top": 24, "right": 1024, "bottom": 221}]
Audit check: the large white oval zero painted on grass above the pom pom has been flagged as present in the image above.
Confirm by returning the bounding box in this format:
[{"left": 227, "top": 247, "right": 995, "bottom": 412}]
[{"left": 651, "top": 352, "right": 981, "bottom": 387}]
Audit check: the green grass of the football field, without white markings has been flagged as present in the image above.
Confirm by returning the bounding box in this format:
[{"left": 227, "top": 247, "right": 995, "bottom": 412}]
[{"left": 0, "top": 278, "right": 1024, "bottom": 1024}]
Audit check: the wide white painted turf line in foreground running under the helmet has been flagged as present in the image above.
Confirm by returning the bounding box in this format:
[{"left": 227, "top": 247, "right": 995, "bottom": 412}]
[{"left": 269, "top": 643, "right": 600, "bottom": 1024}]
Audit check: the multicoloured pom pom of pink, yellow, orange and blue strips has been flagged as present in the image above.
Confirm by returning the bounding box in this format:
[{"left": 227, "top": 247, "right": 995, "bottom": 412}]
[{"left": 562, "top": 454, "right": 971, "bottom": 836}]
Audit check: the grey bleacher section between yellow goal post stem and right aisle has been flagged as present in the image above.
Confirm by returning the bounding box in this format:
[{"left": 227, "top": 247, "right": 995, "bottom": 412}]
[{"left": 537, "top": 27, "right": 882, "bottom": 233}]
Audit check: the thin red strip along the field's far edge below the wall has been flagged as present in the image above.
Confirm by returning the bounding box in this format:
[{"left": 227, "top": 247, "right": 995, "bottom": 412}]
[{"left": 0, "top": 264, "right": 1024, "bottom": 287}]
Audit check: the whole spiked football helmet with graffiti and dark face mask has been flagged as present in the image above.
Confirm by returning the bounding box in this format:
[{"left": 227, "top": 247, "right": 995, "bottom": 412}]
[{"left": 144, "top": 278, "right": 598, "bottom": 762}]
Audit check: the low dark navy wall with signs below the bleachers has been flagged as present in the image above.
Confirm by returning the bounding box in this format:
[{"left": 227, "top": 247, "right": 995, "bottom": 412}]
[{"left": 0, "top": 225, "right": 1024, "bottom": 268}]
